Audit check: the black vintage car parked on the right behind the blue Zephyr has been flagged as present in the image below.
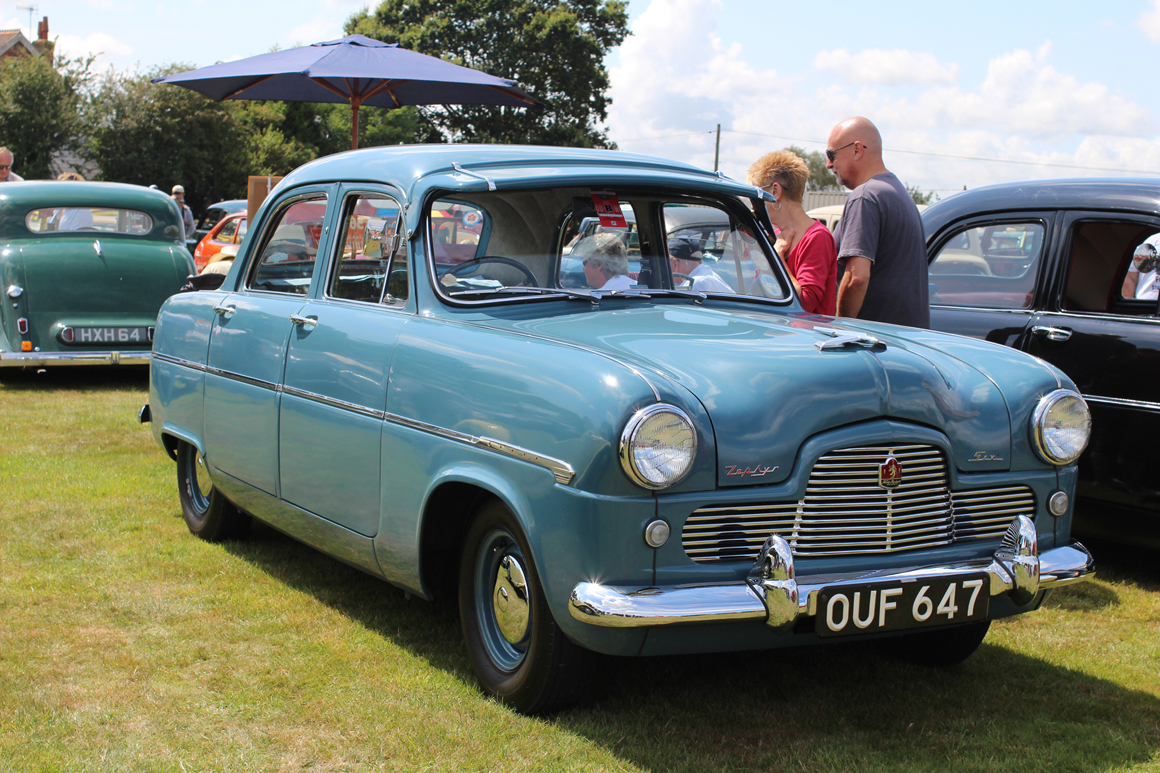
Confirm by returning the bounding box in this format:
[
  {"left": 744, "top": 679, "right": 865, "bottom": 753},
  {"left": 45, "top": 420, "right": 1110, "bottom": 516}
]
[{"left": 922, "top": 179, "right": 1160, "bottom": 548}]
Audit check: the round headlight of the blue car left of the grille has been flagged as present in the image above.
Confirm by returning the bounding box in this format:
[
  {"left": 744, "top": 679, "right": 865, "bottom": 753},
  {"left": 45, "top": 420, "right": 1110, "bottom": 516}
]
[{"left": 621, "top": 405, "right": 697, "bottom": 489}]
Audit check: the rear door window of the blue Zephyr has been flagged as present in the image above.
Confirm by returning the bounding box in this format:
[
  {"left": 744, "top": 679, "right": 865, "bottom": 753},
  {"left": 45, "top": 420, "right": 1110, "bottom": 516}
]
[{"left": 248, "top": 195, "right": 326, "bottom": 295}]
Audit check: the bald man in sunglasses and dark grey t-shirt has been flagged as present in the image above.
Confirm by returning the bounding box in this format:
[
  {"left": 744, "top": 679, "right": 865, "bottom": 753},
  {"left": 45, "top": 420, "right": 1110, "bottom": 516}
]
[{"left": 826, "top": 117, "right": 930, "bottom": 327}]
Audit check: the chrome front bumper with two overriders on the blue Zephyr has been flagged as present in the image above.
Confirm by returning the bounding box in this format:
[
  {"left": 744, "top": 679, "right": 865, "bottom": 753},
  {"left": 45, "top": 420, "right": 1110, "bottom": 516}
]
[{"left": 568, "top": 515, "right": 1095, "bottom": 631}]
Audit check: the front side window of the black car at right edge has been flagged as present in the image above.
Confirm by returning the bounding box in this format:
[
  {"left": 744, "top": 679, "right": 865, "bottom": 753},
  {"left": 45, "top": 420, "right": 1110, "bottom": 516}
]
[{"left": 1064, "top": 221, "right": 1157, "bottom": 315}]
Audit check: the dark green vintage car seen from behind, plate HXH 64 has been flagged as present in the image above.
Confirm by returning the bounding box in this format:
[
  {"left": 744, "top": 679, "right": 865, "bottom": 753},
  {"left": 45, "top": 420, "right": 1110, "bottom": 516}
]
[{"left": 0, "top": 181, "right": 194, "bottom": 368}]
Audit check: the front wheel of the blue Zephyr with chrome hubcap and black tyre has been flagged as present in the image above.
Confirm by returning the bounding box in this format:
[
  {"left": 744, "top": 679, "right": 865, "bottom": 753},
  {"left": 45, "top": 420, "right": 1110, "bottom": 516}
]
[{"left": 459, "top": 501, "right": 592, "bottom": 714}]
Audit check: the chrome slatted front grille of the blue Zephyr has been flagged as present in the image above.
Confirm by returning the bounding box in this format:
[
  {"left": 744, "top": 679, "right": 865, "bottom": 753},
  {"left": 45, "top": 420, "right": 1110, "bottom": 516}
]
[{"left": 681, "top": 446, "right": 1035, "bottom": 562}]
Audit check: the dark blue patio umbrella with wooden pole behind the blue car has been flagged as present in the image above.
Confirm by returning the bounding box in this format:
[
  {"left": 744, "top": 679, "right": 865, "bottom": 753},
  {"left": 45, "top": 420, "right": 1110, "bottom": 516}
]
[{"left": 153, "top": 35, "right": 544, "bottom": 149}]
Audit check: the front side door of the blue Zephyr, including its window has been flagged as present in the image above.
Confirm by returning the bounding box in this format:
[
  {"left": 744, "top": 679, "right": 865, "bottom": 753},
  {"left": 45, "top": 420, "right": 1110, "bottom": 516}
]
[{"left": 278, "top": 186, "right": 411, "bottom": 536}]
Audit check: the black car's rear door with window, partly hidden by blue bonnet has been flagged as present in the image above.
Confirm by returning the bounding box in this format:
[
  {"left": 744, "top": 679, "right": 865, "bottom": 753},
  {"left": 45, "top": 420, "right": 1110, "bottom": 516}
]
[{"left": 928, "top": 211, "right": 1056, "bottom": 346}]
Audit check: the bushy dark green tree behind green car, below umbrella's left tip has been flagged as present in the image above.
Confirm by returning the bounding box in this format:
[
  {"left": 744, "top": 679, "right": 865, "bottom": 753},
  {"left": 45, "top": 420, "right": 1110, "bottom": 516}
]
[{"left": 87, "top": 65, "right": 253, "bottom": 212}]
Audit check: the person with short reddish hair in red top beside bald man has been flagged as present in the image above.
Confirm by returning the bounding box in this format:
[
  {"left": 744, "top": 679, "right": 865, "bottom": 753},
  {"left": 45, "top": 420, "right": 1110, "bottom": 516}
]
[{"left": 747, "top": 150, "right": 838, "bottom": 317}]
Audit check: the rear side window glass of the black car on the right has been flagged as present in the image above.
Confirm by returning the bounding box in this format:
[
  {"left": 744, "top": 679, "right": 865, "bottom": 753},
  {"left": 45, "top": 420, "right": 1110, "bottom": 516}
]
[{"left": 930, "top": 222, "right": 1046, "bottom": 309}]
